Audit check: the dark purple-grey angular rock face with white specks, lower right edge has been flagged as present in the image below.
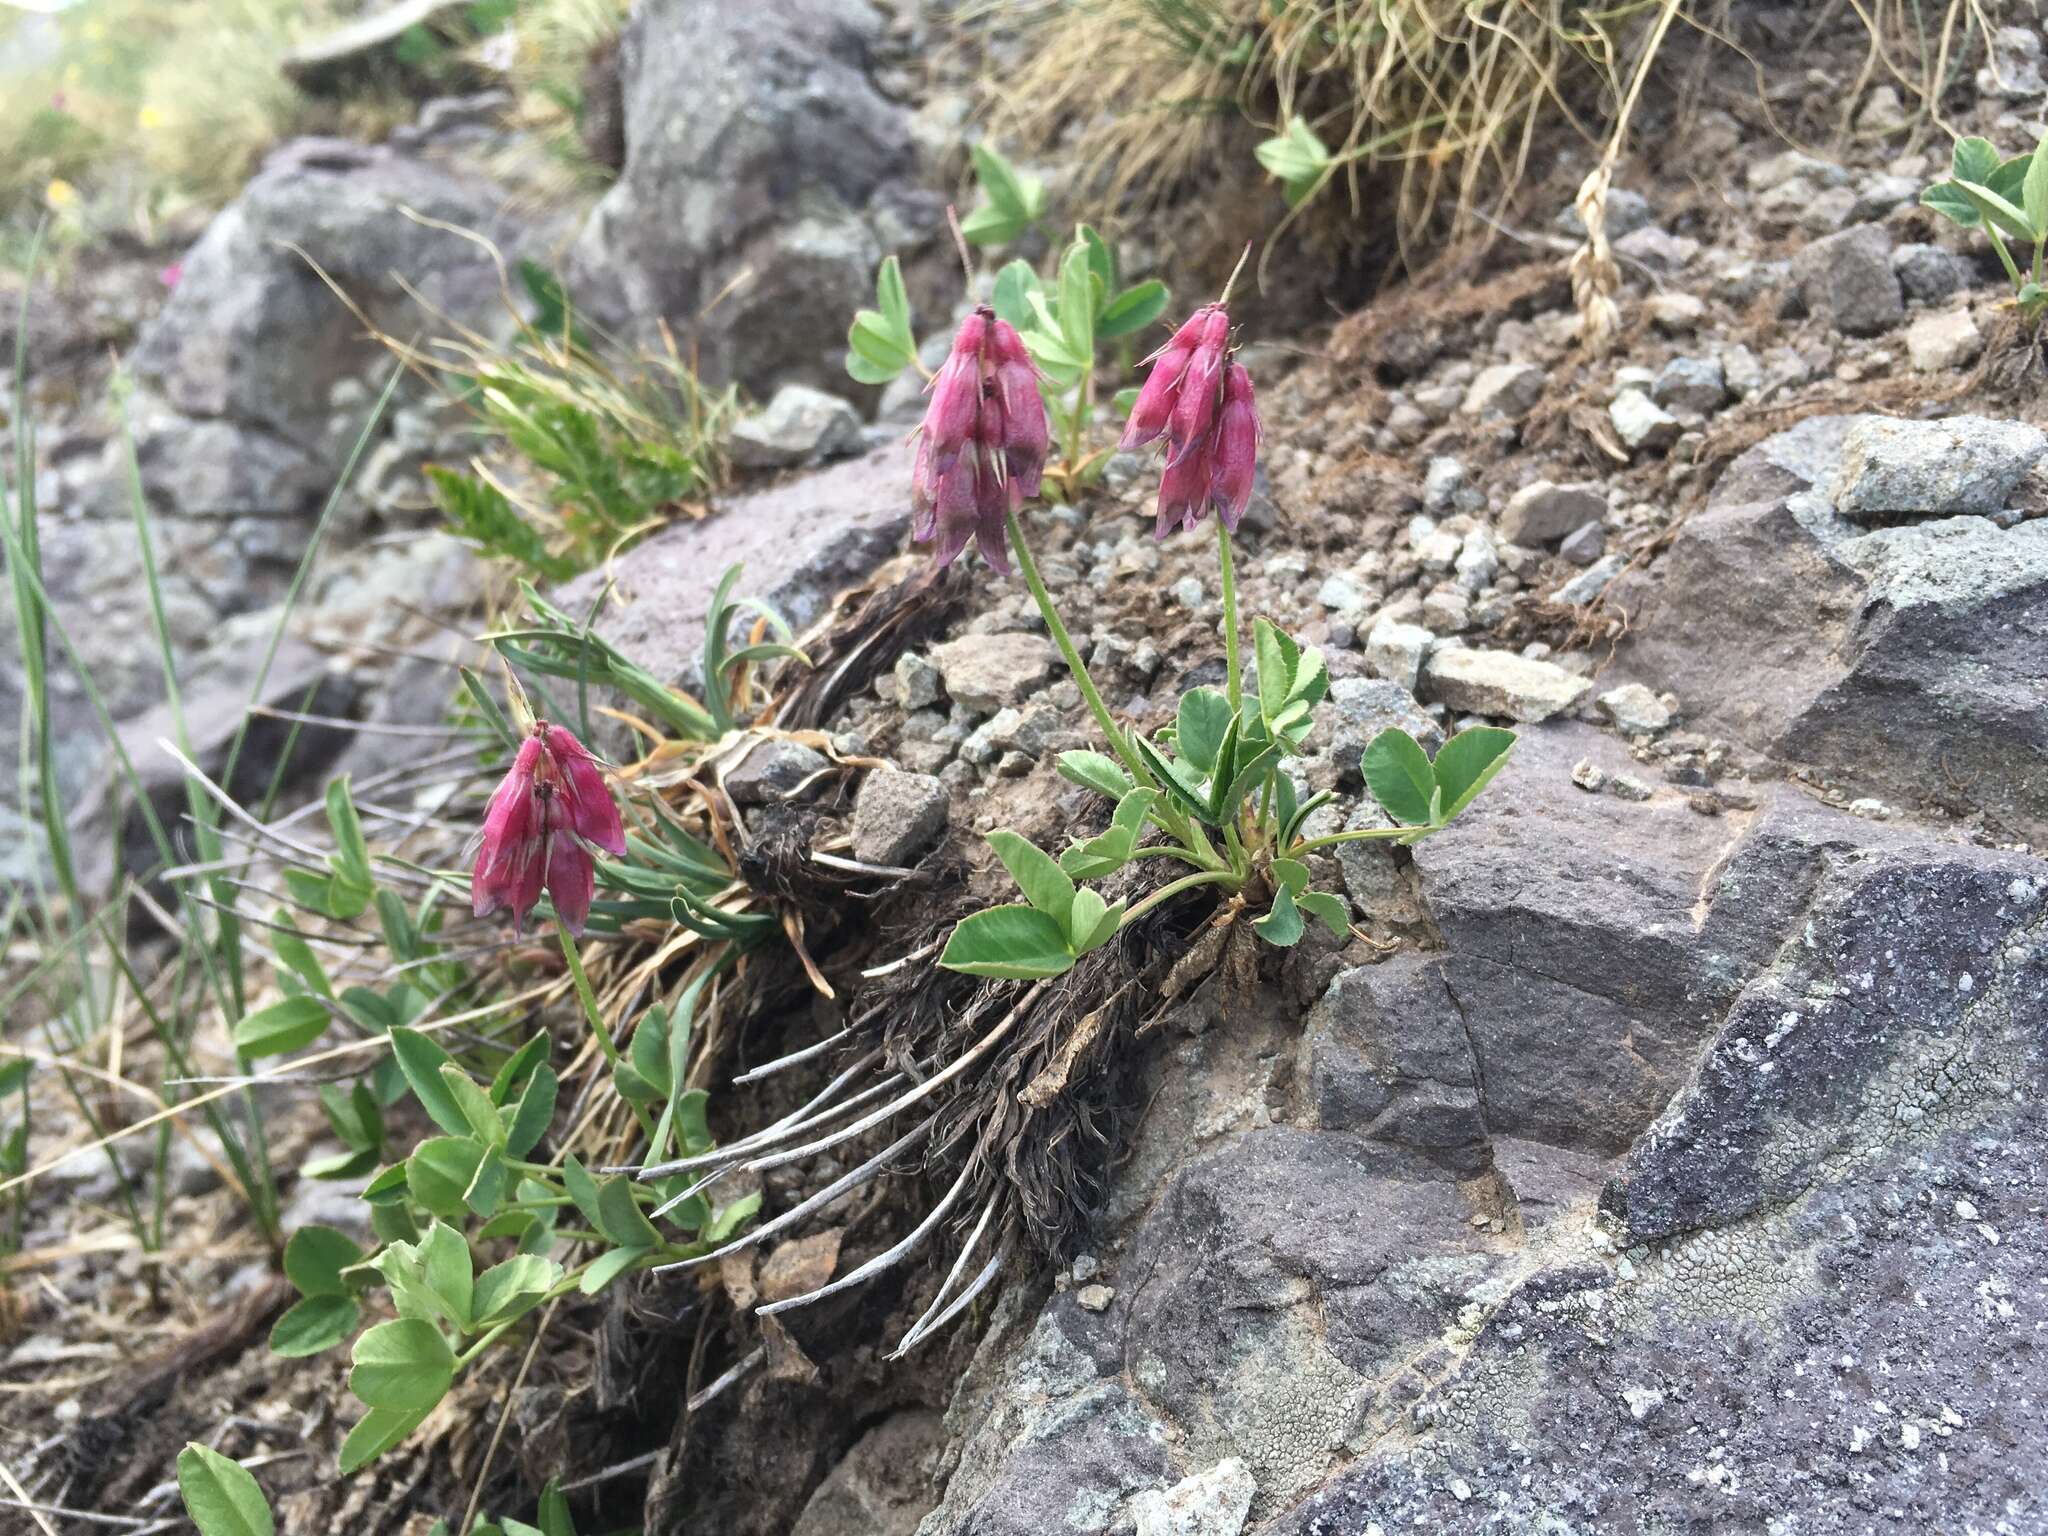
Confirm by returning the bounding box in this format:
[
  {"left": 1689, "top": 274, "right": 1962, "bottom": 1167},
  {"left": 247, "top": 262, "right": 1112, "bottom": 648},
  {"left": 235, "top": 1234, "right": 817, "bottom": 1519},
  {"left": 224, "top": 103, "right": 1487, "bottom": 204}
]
[{"left": 1602, "top": 842, "right": 2048, "bottom": 1243}]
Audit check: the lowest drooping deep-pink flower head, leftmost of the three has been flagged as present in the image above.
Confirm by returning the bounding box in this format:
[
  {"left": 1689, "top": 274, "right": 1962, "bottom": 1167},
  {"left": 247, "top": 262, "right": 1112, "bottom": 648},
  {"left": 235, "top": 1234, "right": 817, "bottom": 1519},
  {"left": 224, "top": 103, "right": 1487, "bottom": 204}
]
[{"left": 469, "top": 721, "right": 627, "bottom": 934}]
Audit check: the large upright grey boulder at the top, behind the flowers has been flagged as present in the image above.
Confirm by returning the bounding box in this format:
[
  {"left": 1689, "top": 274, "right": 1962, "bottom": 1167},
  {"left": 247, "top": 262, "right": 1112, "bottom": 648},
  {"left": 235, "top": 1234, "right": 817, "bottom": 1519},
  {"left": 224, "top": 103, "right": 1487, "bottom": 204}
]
[{"left": 571, "top": 0, "right": 913, "bottom": 397}]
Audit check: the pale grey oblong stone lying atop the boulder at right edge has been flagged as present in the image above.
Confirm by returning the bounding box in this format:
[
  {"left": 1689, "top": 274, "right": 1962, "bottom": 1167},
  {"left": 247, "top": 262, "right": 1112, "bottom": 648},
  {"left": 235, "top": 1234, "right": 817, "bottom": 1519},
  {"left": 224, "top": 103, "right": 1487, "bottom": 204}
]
[{"left": 1833, "top": 416, "right": 2048, "bottom": 518}]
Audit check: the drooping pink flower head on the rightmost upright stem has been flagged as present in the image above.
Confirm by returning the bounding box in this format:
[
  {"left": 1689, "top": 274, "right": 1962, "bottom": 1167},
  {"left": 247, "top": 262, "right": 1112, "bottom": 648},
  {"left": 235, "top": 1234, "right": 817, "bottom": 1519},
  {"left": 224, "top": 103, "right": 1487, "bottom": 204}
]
[{"left": 1120, "top": 303, "right": 1260, "bottom": 539}]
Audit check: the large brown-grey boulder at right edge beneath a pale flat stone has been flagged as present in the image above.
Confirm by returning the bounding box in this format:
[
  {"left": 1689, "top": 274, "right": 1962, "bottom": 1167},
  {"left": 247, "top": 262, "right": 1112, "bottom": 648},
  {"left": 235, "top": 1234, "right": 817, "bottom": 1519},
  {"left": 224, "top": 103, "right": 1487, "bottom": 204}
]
[{"left": 1610, "top": 418, "right": 2048, "bottom": 840}]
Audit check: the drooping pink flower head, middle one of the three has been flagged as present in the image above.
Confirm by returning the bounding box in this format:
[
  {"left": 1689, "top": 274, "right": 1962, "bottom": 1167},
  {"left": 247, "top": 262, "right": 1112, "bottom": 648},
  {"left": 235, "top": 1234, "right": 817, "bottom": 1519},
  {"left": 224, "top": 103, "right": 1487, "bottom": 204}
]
[{"left": 911, "top": 305, "right": 1053, "bottom": 575}]
